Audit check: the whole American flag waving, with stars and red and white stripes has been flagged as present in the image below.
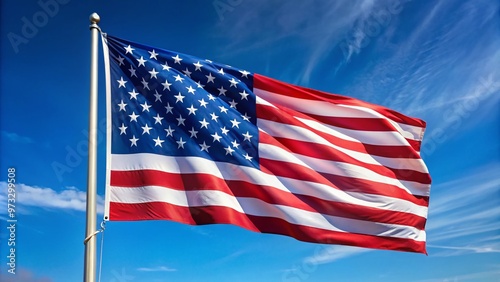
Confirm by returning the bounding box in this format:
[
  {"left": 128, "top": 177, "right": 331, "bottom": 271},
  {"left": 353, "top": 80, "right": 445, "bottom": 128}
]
[{"left": 103, "top": 35, "right": 431, "bottom": 253}]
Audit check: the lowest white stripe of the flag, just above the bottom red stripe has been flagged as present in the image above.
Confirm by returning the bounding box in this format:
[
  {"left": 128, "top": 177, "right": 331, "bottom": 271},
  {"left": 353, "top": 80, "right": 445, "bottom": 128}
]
[{"left": 111, "top": 186, "right": 425, "bottom": 241}]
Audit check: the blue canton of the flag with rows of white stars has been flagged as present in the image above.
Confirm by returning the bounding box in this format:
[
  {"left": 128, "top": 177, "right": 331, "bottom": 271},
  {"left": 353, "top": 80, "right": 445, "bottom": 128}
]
[{"left": 107, "top": 35, "right": 259, "bottom": 168}]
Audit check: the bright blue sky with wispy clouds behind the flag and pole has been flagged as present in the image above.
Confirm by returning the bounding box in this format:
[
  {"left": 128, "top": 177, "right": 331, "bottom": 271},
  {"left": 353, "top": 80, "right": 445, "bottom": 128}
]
[{"left": 0, "top": 0, "right": 500, "bottom": 282}]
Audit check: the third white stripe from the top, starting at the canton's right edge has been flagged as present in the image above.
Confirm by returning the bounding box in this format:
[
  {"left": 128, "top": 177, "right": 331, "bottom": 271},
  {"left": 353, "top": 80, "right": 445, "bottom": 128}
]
[{"left": 259, "top": 143, "right": 430, "bottom": 195}]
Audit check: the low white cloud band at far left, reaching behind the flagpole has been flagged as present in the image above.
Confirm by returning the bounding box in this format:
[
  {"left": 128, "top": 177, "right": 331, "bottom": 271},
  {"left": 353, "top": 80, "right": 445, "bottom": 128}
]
[{"left": 0, "top": 182, "right": 104, "bottom": 214}]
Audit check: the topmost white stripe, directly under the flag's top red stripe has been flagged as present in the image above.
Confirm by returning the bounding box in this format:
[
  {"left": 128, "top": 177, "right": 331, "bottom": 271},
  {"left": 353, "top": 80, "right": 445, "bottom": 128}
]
[{"left": 254, "top": 88, "right": 423, "bottom": 141}]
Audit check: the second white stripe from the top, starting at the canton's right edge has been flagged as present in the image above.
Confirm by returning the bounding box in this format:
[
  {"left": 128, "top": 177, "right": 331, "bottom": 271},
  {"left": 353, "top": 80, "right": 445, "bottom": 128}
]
[{"left": 257, "top": 119, "right": 428, "bottom": 173}]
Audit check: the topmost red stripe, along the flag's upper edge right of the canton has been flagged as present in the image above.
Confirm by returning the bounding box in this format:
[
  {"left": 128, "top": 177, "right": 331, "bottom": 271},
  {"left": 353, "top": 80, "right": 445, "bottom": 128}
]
[{"left": 253, "top": 74, "right": 426, "bottom": 128}]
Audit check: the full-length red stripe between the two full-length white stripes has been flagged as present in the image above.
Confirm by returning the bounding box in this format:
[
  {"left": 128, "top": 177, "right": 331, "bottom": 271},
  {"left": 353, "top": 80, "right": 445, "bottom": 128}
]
[{"left": 111, "top": 170, "right": 426, "bottom": 230}]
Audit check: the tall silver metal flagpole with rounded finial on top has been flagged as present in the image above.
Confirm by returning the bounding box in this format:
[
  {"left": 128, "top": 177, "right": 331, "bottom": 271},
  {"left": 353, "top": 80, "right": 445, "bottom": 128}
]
[{"left": 83, "top": 13, "right": 100, "bottom": 282}]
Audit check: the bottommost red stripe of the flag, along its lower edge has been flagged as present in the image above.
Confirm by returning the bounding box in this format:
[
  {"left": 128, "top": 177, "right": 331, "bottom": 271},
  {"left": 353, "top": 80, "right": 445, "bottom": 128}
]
[{"left": 109, "top": 202, "right": 426, "bottom": 253}]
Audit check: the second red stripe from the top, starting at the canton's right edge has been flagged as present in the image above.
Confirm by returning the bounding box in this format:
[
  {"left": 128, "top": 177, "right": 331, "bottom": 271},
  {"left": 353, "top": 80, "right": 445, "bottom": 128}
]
[{"left": 257, "top": 105, "right": 420, "bottom": 159}]
